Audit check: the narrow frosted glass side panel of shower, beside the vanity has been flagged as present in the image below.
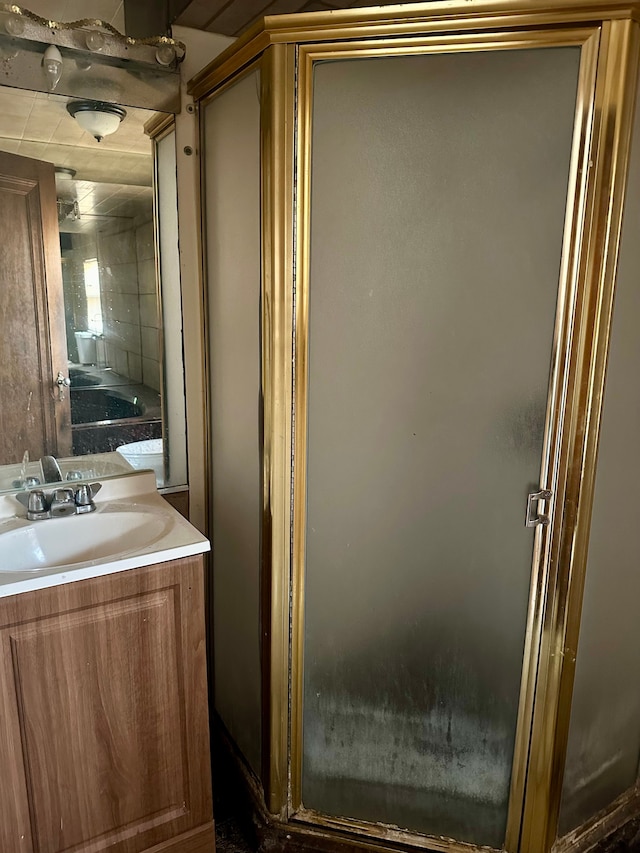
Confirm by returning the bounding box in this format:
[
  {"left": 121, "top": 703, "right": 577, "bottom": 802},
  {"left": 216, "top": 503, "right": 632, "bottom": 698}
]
[{"left": 203, "top": 70, "right": 262, "bottom": 774}]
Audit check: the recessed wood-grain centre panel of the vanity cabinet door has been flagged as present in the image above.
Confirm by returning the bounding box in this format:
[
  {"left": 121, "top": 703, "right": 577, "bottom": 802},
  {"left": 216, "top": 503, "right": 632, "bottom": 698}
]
[{"left": 10, "top": 589, "right": 187, "bottom": 853}]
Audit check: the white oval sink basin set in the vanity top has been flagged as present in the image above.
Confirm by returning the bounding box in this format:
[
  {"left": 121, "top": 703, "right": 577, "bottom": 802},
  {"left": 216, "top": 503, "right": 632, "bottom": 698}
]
[{"left": 0, "top": 507, "right": 172, "bottom": 572}]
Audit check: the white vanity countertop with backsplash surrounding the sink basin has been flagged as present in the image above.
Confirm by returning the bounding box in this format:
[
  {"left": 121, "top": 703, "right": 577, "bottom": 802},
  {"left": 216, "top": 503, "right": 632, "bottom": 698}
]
[{"left": 0, "top": 471, "right": 210, "bottom": 597}]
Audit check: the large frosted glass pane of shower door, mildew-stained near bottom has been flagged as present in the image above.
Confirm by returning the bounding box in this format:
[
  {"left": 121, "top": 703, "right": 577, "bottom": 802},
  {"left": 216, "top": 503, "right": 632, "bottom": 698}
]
[{"left": 302, "top": 47, "right": 580, "bottom": 848}]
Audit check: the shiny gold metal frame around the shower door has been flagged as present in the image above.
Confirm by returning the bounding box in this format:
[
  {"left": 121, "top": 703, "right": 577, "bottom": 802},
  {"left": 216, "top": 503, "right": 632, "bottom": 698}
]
[{"left": 189, "top": 0, "right": 640, "bottom": 853}]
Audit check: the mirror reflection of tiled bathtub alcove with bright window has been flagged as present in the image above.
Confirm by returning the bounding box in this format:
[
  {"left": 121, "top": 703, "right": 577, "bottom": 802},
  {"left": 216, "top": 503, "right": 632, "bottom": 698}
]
[{"left": 60, "top": 171, "right": 162, "bottom": 456}]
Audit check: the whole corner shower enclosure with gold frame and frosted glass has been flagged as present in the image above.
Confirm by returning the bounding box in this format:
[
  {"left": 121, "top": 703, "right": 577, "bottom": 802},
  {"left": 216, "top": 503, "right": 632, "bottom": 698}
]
[{"left": 190, "top": 0, "right": 640, "bottom": 853}]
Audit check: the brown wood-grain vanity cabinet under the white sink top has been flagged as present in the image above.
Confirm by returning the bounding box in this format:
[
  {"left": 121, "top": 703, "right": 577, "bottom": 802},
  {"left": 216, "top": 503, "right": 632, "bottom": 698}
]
[{"left": 0, "top": 556, "right": 214, "bottom": 853}]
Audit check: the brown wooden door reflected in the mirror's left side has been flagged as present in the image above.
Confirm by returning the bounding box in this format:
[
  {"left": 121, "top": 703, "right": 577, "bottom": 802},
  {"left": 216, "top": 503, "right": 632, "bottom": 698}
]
[{"left": 0, "top": 152, "right": 71, "bottom": 465}]
